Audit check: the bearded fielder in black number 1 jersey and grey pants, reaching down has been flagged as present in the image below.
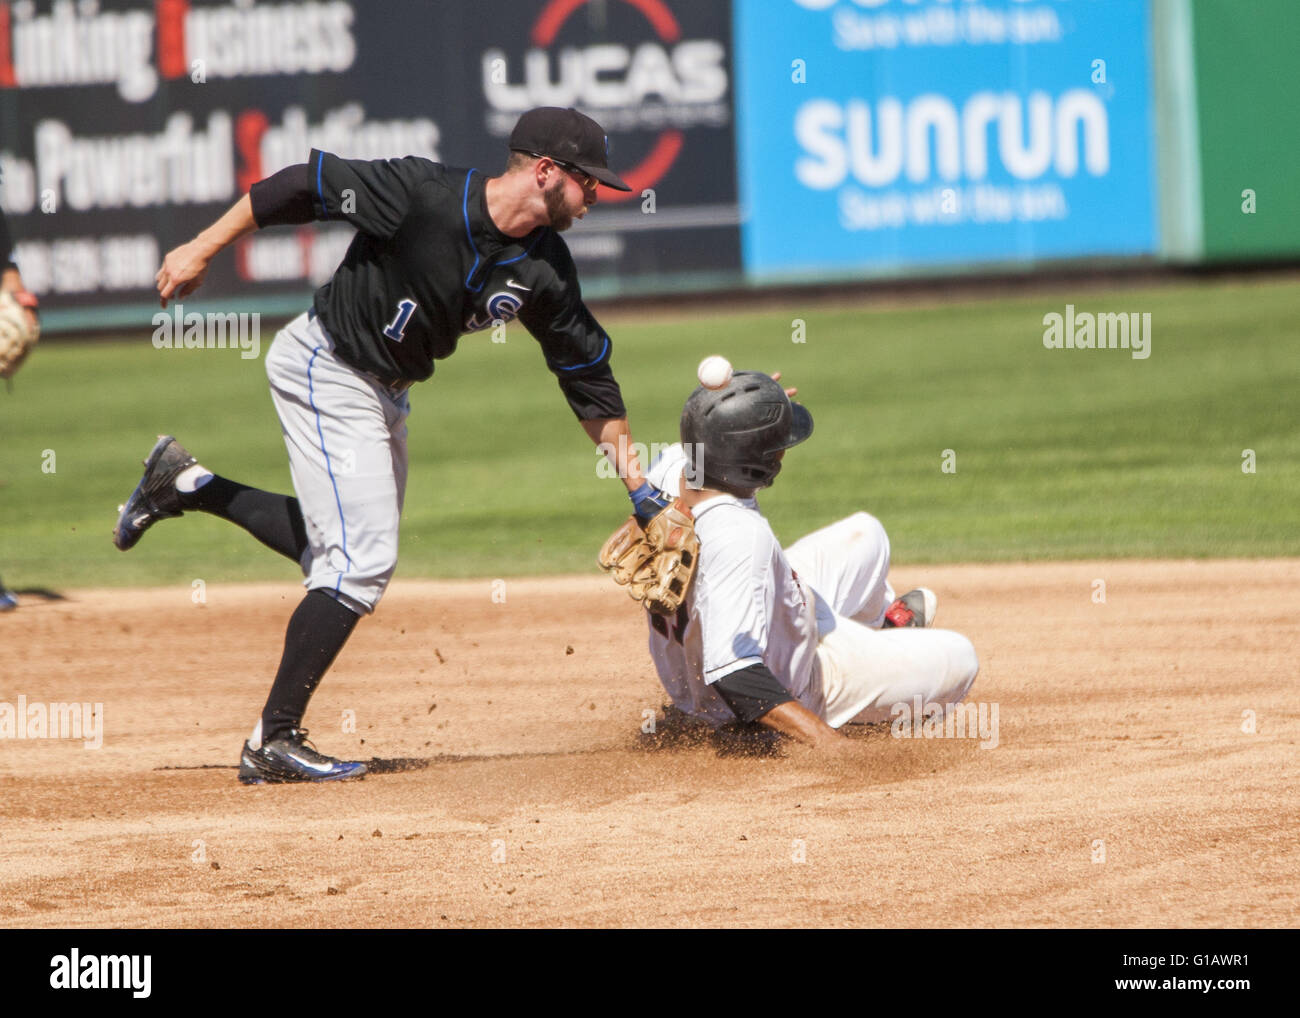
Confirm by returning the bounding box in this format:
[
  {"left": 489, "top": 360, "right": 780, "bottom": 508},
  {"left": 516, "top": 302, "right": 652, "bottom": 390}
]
[{"left": 113, "top": 107, "right": 667, "bottom": 784}]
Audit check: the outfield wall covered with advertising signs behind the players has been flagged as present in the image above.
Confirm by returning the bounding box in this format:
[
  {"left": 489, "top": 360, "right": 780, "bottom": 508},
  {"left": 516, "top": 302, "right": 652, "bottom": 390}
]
[{"left": 0, "top": 0, "right": 1300, "bottom": 332}]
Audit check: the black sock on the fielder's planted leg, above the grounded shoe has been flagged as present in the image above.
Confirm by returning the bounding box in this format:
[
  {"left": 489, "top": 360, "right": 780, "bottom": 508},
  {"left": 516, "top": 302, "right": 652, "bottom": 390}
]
[{"left": 261, "top": 590, "right": 361, "bottom": 744}]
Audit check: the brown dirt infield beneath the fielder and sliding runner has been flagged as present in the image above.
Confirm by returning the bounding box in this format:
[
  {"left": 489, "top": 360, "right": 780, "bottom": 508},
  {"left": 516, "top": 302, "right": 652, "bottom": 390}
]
[{"left": 0, "top": 560, "right": 1300, "bottom": 927}]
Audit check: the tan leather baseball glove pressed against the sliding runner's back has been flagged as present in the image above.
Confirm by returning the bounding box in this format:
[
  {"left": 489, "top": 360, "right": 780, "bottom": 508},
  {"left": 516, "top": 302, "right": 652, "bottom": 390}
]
[{"left": 599, "top": 502, "right": 699, "bottom": 615}]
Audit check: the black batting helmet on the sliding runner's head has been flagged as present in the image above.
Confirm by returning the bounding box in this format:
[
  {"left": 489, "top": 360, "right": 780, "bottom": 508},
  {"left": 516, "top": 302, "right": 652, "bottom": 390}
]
[{"left": 681, "top": 371, "right": 813, "bottom": 495}]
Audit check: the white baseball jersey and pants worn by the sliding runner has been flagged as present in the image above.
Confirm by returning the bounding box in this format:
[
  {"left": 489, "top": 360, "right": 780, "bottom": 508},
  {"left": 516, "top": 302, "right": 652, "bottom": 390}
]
[{"left": 646, "top": 445, "right": 979, "bottom": 728}]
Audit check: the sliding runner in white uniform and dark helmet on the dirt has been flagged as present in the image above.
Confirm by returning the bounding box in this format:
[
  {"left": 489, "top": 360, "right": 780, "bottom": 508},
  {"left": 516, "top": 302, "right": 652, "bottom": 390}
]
[{"left": 601, "top": 367, "right": 979, "bottom": 748}]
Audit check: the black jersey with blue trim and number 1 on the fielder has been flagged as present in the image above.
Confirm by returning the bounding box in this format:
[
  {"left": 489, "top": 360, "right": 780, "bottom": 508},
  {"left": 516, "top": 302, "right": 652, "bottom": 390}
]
[{"left": 293, "top": 150, "right": 625, "bottom": 417}]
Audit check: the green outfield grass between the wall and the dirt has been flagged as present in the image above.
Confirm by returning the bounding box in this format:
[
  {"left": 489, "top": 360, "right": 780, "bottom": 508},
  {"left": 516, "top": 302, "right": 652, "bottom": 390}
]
[{"left": 0, "top": 274, "right": 1300, "bottom": 588}]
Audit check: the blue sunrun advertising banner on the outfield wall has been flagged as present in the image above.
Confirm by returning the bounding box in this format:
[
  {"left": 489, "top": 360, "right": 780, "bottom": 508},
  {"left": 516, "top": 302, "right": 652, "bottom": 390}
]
[{"left": 735, "top": 0, "right": 1157, "bottom": 280}]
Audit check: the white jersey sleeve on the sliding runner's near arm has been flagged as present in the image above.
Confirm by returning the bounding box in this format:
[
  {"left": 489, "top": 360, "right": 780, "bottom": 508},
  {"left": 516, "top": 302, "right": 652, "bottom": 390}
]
[{"left": 696, "top": 527, "right": 776, "bottom": 685}]
